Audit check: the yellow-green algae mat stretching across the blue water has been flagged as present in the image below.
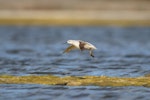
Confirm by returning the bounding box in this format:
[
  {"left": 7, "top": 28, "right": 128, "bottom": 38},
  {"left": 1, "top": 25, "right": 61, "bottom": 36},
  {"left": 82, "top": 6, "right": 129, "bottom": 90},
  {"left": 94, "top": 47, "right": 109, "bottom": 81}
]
[{"left": 0, "top": 75, "right": 150, "bottom": 87}]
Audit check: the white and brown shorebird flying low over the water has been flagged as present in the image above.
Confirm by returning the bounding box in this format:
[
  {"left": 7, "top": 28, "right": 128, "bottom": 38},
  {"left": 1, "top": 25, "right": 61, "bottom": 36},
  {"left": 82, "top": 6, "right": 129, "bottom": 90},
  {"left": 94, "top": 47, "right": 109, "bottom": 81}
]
[{"left": 63, "top": 40, "right": 97, "bottom": 57}]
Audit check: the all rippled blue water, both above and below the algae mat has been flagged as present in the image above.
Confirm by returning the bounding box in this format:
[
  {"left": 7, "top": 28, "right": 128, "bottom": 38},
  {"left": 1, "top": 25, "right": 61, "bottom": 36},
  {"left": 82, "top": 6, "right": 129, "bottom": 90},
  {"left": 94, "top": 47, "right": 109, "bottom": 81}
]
[{"left": 0, "top": 26, "right": 150, "bottom": 100}]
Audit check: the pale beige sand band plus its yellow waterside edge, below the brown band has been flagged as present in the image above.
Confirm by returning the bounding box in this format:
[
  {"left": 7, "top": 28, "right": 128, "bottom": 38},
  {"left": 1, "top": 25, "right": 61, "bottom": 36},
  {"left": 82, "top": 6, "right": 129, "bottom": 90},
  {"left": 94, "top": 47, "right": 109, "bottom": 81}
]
[{"left": 0, "top": 10, "right": 150, "bottom": 25}]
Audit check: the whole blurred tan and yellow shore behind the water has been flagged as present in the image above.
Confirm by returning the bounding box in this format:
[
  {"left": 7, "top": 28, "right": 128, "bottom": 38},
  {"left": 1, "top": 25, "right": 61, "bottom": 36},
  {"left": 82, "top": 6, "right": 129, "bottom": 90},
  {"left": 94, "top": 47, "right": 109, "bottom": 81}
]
[{"left": 0, "top": 0, "right": 150, "bottom": 25}]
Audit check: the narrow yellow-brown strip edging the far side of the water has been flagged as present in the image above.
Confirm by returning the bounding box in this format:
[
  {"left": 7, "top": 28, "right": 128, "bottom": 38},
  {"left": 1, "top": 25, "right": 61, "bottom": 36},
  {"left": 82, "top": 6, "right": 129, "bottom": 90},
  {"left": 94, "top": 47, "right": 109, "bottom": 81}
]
[{"left": 0, "top": 18, "right": 150, "bottom": 26}]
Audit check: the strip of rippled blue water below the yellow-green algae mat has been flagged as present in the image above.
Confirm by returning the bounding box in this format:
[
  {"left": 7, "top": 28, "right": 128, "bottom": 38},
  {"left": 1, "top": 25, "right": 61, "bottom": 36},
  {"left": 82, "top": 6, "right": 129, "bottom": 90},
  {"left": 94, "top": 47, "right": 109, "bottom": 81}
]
[{"left": 0, "top": 84, "right": 150, "bottom": 100}]
